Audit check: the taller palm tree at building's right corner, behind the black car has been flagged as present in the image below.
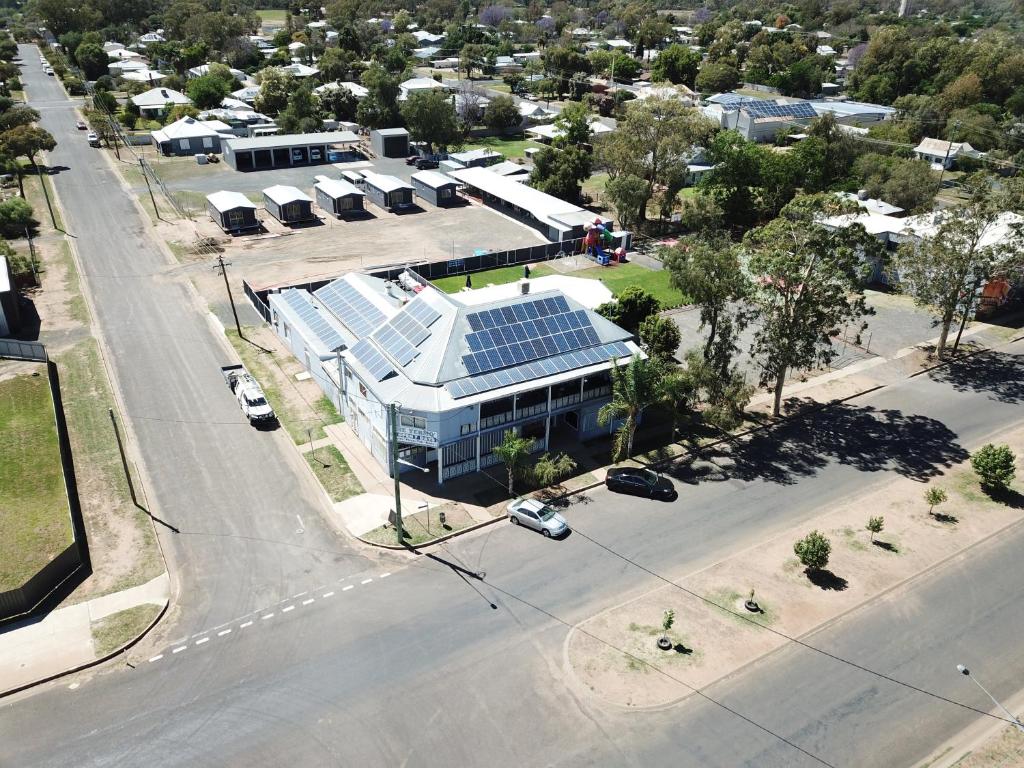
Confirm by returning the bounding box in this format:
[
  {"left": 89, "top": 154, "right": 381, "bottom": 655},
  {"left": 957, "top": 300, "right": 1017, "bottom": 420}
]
[{"left": 597, "top": 356, "right": 676, "bottom": 461}]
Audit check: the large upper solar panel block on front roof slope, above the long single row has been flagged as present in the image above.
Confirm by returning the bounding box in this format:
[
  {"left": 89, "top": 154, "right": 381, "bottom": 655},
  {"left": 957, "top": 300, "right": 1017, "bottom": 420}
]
[{"left": 462, "top": 296, "right": 598, "bottom": 376}]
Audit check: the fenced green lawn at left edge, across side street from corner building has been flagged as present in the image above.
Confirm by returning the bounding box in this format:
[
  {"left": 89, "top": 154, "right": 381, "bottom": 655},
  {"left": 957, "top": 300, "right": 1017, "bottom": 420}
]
[{"left": 0, "top": 365, "right": 74, "bottom": 591}]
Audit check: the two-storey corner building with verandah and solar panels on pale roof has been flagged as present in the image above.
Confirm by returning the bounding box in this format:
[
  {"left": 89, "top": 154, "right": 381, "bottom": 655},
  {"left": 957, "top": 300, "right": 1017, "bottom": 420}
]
[{"left": 268, "top": 271, "right": 643, "bottom": 483}]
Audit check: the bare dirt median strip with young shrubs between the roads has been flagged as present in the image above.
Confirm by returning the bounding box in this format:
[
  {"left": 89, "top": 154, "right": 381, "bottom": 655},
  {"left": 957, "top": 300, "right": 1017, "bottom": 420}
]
[{"left": 566, "top": 429, "right": 1024, "bottom": 708}]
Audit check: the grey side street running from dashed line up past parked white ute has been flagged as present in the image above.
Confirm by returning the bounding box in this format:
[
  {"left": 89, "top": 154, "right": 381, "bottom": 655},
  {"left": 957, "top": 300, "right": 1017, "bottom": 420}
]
[{"left": 19, "top": 45, "right": 376, "bottom": 632}]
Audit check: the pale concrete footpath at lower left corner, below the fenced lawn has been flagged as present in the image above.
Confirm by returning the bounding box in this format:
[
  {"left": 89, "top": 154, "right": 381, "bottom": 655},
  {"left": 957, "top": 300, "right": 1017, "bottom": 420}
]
[{"left": 0, "top": 572, "right": 170, "bottom": 695}]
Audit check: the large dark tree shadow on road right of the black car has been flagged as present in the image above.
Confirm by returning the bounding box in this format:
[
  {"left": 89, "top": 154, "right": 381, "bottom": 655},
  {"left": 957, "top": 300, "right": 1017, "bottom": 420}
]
[{"left": 680, "top": 403, "right": 969, "bottom": 484}]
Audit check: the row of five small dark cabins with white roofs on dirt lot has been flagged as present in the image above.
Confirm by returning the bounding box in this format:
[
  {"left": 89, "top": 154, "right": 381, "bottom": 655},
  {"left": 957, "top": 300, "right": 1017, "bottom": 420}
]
[{"left": 207, "top": 171, "right": 457, "bottom": 233}]
